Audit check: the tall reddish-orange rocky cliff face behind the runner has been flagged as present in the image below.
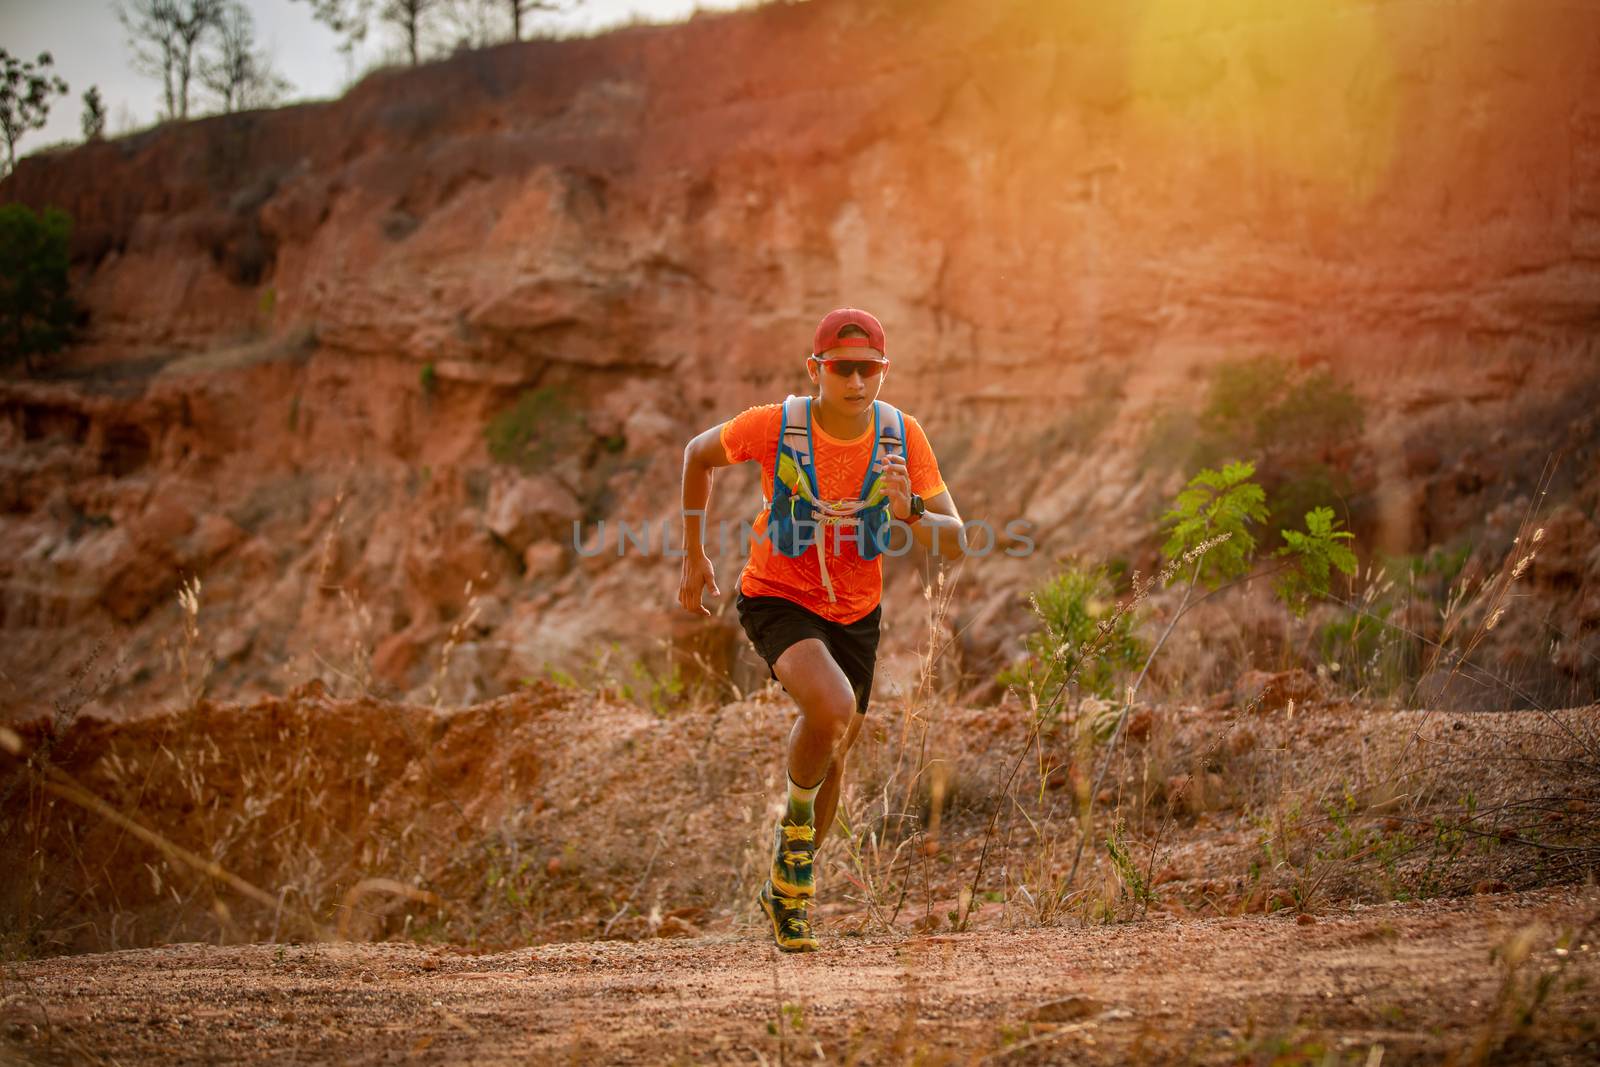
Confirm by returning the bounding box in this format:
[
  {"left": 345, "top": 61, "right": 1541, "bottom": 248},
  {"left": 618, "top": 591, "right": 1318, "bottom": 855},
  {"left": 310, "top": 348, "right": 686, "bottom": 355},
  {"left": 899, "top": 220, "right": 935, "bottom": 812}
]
[{"left": 0, "top": 0, "right": 1600, "bottom": 713}]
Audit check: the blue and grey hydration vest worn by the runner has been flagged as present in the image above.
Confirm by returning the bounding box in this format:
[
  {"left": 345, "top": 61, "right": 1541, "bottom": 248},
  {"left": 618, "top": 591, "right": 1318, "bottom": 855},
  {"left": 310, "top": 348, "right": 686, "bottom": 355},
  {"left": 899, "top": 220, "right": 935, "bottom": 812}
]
[{"left": 766, "top": 397, "right": 906, "bottom": 603}]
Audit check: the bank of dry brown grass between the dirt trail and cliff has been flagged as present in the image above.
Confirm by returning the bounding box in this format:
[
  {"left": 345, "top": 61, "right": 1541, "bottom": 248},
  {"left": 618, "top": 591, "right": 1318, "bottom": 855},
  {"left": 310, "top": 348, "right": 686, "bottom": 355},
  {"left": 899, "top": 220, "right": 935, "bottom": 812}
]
[{"left": 0, "top": 473, "right": 1600, "bottom": 955}]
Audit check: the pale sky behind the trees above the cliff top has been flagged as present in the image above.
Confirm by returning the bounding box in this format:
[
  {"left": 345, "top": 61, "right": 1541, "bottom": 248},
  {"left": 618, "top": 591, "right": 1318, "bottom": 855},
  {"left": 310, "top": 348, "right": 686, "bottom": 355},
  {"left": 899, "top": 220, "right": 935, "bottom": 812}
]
[{"left": 0, "top": 0, "right": 749, "bottom": 157}]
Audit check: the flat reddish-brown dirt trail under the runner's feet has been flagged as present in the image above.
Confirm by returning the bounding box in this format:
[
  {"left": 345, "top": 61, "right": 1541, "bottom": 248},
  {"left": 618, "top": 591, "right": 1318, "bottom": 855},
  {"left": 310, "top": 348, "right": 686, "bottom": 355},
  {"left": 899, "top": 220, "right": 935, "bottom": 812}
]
[{"left": 0, "top": 886, "right": 1600, "bottom": 1064}]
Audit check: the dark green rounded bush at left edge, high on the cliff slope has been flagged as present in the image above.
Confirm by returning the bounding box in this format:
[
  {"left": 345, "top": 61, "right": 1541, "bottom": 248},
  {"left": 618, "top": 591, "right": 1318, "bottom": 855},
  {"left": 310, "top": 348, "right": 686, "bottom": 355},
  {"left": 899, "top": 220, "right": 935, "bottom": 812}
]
[{"left": 0, "top": 203, "right": 78, "bottom": 374}]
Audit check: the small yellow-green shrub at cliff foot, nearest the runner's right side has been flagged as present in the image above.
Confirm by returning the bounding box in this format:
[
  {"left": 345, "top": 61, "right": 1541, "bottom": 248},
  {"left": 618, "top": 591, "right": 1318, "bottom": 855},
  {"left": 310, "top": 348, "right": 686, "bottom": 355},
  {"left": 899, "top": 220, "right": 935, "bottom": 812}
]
[{"left": 1000, "top": 566, "right": 1147, "bottom": 697}]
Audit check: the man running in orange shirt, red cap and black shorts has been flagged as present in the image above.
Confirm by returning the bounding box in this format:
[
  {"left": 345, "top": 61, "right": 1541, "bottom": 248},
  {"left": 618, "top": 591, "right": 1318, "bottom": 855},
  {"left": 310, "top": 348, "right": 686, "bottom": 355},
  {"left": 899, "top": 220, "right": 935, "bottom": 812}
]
[{"left": 678, "top": 307, "right": 965, "bottom": 952}]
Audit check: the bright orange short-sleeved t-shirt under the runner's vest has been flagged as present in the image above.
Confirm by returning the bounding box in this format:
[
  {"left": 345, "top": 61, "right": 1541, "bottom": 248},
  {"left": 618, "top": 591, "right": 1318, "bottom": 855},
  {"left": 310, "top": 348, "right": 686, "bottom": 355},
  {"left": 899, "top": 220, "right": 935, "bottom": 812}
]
[{"left": 722, "top": 403, "right": 944, "bottom": 622}]
